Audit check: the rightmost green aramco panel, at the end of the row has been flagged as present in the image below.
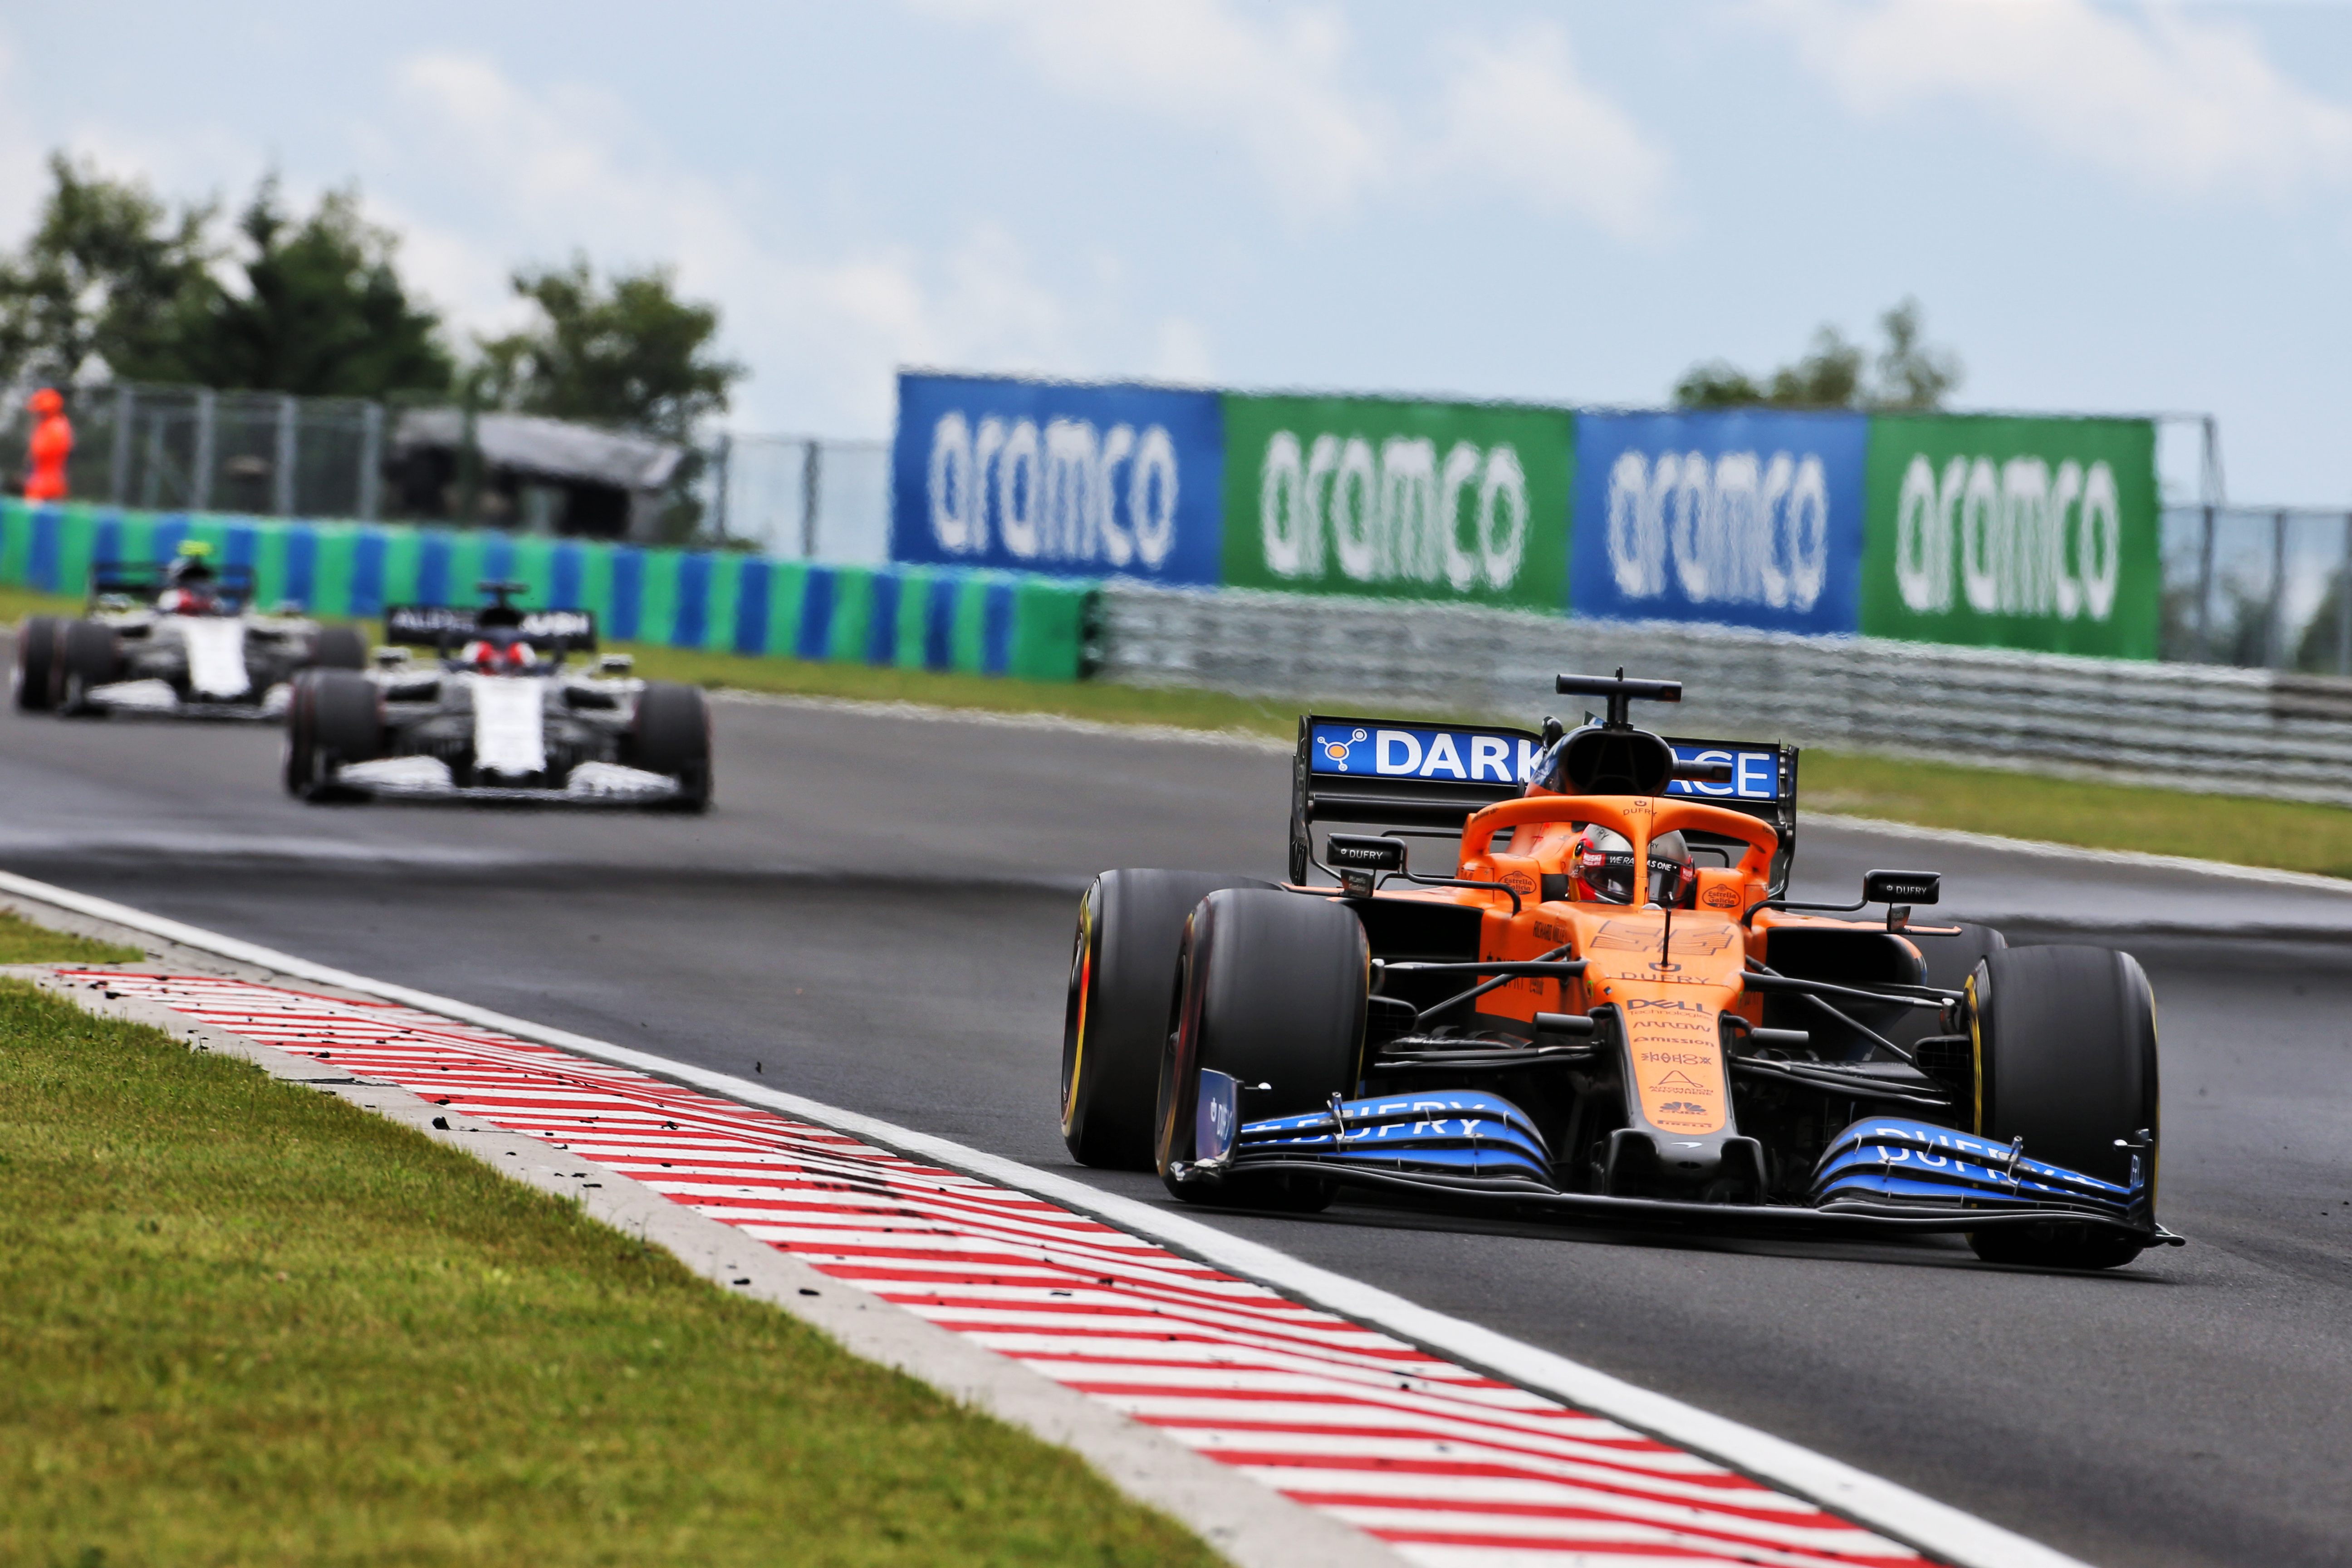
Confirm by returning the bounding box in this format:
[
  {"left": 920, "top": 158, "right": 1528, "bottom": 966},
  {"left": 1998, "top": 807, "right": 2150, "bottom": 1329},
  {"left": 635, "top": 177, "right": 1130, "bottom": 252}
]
[{"left": 1863, "top": 414, "right": 2161, "bottom": 658}]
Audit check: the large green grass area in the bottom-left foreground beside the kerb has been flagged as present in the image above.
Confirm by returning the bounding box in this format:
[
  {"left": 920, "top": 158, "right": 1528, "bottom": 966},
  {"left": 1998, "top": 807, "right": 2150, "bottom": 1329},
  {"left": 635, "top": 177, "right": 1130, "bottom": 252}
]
[{"left": 0, "top": 983, "right": 1216, "bottom": 1566}]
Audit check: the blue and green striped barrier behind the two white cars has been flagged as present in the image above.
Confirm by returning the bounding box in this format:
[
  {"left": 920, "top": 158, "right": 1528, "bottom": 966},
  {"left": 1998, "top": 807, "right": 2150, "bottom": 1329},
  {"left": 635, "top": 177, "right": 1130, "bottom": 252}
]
[{"left": 0, "top": 501, "right": 1094, "bottom": 682}]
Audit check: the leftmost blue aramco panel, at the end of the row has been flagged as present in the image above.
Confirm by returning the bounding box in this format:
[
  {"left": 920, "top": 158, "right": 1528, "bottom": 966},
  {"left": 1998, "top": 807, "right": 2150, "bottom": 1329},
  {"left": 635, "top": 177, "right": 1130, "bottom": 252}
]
[{"left": 892, "top": 372, "right": 1225, "bottom": 585}]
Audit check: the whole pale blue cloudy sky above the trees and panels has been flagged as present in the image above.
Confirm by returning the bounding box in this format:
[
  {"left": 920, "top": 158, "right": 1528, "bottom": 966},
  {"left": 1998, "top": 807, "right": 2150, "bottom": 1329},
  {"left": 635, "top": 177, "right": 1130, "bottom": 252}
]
[{"left": 0, "top": 0, "right": 2352, "bottom": 505}]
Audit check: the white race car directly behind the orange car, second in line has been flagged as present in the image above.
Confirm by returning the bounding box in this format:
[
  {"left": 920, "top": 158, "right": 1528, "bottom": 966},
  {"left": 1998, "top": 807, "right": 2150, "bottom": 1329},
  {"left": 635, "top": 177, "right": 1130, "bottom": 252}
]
[{"left": 284, "top": 583, "right": 710, "bottom": 811}]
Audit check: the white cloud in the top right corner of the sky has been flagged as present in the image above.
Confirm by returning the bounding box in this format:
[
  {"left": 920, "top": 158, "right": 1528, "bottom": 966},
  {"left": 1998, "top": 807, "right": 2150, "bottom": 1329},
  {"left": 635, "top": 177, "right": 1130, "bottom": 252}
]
[{"left": 1757, "top": 0, "right": 2352, "bottom": 197}]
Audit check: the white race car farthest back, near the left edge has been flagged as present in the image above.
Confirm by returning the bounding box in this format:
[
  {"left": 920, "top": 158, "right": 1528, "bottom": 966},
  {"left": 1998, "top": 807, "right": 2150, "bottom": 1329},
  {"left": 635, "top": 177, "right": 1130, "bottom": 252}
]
[{"left": 16, "top": 541, "right": 367, "bottom": 720}]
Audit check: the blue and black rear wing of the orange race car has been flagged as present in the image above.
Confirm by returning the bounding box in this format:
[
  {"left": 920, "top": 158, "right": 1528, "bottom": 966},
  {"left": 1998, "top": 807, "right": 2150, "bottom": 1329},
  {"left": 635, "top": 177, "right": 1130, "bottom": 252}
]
[{"left": 1291, "top": 715, "right": 1797, "bottom": 898}]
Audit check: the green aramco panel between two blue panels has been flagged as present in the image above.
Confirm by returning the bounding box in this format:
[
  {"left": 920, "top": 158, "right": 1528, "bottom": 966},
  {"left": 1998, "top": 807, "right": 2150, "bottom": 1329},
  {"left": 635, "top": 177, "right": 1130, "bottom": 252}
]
[{"left": 1225, "top": 395, "right": 1573, "bottom": 611}]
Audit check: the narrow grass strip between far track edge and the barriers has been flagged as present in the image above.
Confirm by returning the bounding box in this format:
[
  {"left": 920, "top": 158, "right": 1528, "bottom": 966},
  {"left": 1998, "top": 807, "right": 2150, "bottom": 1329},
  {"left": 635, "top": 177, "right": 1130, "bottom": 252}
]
[{"left": 14, "top": 588, "right": 2352, "bottom": 877}]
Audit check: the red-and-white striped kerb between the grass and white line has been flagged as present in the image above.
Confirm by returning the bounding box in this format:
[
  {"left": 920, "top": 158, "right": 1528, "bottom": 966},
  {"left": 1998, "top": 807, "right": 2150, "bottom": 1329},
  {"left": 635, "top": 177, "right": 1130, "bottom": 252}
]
[{"left": 87, "top": 971, "right": 1924, "bottom": 1568}]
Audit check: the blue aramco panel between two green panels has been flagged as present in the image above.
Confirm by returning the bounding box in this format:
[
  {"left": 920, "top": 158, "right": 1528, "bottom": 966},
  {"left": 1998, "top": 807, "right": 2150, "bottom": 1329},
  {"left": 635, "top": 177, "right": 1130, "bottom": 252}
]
[{"left": 1569, "top": 409, "right": 1870, "bottom": 635}]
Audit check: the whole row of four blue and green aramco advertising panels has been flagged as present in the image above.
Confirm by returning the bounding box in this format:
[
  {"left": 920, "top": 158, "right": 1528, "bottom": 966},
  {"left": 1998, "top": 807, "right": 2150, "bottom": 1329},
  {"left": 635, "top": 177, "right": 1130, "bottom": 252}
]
[{"left": 892, "top": 372, "right": 2161, "bottom": 658}]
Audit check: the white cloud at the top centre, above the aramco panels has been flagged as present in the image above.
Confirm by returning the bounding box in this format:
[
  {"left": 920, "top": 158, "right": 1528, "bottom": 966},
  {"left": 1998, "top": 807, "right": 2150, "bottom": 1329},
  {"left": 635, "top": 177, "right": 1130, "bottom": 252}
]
[{"left": 915, "top": 0, "right": 1670, "bottom": 237}]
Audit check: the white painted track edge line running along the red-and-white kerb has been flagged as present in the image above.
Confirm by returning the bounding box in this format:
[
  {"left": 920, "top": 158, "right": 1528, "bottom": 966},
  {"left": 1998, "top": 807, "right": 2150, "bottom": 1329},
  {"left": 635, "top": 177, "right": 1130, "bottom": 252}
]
[{"left": 0, "top": 870, "right": 2088, "bottom": 1568}]
